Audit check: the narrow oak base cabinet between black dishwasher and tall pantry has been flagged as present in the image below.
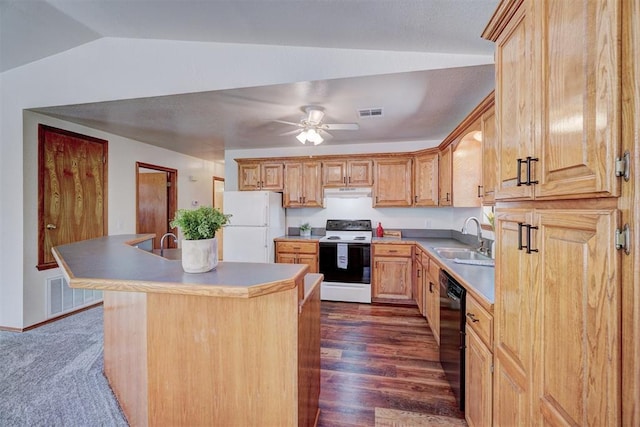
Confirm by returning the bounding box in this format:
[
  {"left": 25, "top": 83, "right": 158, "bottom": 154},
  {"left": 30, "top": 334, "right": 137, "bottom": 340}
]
[{"left": 464, "top": 293, "right": 493, "bottom": 427}]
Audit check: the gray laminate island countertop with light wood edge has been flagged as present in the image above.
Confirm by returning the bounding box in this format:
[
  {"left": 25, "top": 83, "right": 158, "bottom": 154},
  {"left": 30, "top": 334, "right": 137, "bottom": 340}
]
[{"left": 53, "top": 234, "right": 309, "bottom": 299}]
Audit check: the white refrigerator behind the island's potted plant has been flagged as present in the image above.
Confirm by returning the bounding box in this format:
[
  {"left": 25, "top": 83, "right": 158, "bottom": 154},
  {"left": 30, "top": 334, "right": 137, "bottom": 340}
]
[{"left": 222, "top": 191, "right": 285, "bottom": 262}]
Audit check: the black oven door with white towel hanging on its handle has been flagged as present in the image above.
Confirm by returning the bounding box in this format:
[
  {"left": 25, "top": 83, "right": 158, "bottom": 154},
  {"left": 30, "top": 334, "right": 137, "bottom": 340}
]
[{"left": 319, "top": 242, "right": 371, "bottom": 284}]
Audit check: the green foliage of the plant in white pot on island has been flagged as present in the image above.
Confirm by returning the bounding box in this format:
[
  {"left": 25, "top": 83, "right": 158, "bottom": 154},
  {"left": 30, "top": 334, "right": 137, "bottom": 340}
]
[{"left": 170, "top": 206, "right": 231, "bottom": 240}]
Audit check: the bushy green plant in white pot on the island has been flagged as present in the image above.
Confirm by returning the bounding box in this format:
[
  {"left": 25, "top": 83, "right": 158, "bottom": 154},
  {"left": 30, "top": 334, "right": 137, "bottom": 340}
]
[{"left": 170, "top": 206, "right": 231, "bottom": 273}]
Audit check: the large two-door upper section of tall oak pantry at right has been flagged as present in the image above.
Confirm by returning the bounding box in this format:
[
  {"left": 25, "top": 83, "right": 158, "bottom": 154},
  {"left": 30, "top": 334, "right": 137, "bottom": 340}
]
[{"left": 483, "top": 0, "right": 621, "bottom": 200}]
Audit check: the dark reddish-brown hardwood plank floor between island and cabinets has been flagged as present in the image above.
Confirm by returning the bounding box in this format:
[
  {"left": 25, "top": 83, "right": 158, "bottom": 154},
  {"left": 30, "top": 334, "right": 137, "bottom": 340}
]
[{"left": 319, "top": 301, "right": 466, "bottom": 427}]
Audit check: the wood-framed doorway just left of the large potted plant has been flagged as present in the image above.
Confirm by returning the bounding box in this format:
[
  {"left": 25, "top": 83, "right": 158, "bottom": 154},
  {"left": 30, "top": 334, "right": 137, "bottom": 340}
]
[{"left": 136, "top": 162, "right": 178, "bottom": 249}]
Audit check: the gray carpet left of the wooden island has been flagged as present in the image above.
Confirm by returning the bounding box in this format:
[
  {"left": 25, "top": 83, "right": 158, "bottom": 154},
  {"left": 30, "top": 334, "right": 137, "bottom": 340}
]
[{"left": 0, "top": 306, "right": 127, "bottom": 427}]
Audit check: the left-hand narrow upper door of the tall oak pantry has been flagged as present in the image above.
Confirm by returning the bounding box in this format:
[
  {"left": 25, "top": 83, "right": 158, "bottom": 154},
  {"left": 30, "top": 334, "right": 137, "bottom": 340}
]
[{"left": 495, "top": 2, "right": 535, "bottom": 200}]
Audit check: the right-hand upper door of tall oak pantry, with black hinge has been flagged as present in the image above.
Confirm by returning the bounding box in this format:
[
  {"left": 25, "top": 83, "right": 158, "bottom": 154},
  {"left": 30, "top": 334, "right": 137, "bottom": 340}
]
[{"left": 527, "top": 0, "right": 621, "bottom": 198}]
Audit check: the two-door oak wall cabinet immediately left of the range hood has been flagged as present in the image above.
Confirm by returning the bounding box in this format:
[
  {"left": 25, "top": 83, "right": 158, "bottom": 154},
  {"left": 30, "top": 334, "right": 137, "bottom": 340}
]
[{"left": 282, "top": 161, "right": 322, "bottom": 208}]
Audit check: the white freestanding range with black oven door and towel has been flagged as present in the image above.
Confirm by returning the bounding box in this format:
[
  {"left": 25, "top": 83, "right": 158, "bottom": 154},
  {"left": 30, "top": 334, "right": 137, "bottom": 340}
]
[{"left": 319, "top": 219, "right": 372, "bottom": 303}]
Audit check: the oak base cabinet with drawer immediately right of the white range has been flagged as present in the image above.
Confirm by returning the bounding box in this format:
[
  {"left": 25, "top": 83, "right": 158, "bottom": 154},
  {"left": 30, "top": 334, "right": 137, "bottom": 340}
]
[{"left": 371, "top": 244, "right": 413, "bottom": 303}]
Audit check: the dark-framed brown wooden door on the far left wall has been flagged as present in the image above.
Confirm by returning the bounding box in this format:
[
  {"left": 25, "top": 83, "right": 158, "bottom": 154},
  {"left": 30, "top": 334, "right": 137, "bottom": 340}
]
[{"left": 37, "top": 125, "right": 108, "bottom": 270}]
